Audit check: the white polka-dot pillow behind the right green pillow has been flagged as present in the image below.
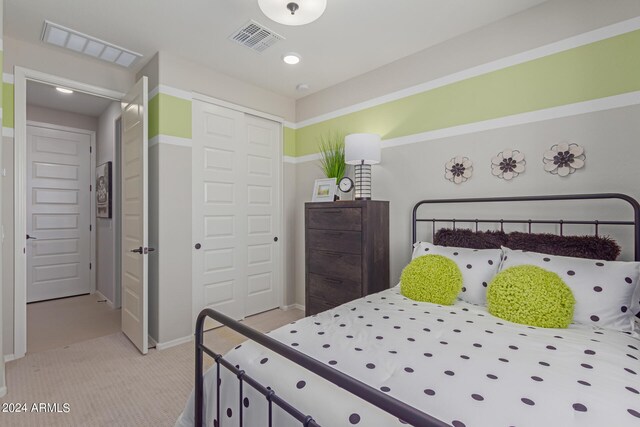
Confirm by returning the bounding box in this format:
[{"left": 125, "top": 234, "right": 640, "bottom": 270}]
[{"left": 500, "top": 247, "right": 640, "bottom": 332}]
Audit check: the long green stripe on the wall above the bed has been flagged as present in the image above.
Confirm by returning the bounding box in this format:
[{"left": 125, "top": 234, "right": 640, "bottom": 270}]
[{"left": 292, "top": 30, "right": 640, "bottom": 157}]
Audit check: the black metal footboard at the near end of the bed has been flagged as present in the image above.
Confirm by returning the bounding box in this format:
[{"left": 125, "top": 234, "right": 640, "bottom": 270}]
[{"left": 195, "top": 309, "right": 448, "bottom": 427}]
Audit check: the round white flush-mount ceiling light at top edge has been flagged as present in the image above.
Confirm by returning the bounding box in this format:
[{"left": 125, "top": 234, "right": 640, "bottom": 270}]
[{"left": 258, "top": 0, "right": 327, "bottom": 25}]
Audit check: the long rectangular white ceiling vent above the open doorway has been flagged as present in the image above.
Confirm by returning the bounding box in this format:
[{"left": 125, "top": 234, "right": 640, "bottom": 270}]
[{"left": 40, "top": 21, "right": 142, "bottom": 68}]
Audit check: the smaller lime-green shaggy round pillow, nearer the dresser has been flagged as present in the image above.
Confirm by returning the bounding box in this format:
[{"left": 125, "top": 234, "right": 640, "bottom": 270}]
[{"left": 400, "top": 255, "right": 462, "bottom": 305}]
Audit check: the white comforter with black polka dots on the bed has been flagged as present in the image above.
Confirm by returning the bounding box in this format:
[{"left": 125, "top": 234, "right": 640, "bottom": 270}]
[{"left": 176, "top": 287, "right": 640, "bottom": 427}]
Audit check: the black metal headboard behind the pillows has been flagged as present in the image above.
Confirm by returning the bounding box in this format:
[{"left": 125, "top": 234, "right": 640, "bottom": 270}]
[{"left": 411, "top": 193, "right": 640, "bottom": 261}]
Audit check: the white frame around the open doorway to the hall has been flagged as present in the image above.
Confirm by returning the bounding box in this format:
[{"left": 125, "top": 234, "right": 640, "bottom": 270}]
[{"left": 13, "top": 67, "right": 124, "bottom": 359}]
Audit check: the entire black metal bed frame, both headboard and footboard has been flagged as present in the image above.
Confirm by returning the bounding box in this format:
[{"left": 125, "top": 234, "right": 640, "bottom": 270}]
[{"left": 194, "top": 193, "right": 640, "bottom": 427}]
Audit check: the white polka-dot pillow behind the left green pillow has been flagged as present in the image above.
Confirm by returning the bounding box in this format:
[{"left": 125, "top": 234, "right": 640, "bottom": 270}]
[{"left": 412, "top": 242, "right": 502, "bottom": 305}]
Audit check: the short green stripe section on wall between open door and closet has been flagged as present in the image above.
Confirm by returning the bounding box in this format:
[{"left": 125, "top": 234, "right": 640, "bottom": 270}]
[{"left": 156, "top": 93, "right": 191, "bottom": 138}]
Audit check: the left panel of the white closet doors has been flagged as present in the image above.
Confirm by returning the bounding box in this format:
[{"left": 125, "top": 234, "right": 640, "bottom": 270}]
[{"left": 192, "top": 101, "right": 247, "bottom": 320}]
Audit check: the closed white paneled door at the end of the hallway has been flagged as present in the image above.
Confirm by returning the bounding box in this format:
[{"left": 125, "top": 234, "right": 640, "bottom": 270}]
[{"left": 26, "top": 125, "right": 92, "bottom": 302}]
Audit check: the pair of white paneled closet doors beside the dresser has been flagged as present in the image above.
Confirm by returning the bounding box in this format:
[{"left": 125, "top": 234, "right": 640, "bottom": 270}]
[{"left": 192, "top": 100, "right": 280, "bottom": 328}]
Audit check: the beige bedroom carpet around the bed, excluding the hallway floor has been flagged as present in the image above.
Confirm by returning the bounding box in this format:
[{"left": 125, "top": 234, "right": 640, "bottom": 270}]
[{"left": 0, "top": 310, "right": 303, "bottom": 427}]
